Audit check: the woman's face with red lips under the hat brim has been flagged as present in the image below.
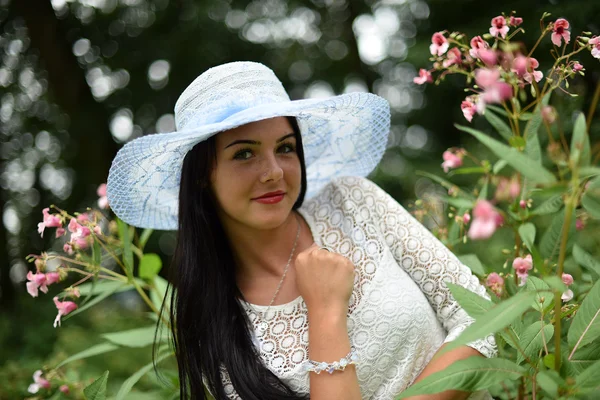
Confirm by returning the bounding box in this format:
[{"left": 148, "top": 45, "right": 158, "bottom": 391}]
[{"left": 211, "top": 117, "right": 302, "bottom": 229}]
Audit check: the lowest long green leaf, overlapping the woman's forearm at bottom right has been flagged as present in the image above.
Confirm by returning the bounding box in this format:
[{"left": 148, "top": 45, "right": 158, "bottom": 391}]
[{"left": 396, "top": 356, "right": 525, "bottom": 399}]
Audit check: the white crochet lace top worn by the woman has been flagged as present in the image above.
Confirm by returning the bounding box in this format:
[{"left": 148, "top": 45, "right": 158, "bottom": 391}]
[{"left": 224, "top": 177, "right": 497, "bottom": 400}]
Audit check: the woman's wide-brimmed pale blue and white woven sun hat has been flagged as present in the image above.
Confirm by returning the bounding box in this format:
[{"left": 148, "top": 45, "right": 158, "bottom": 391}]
[{"left": 107, "top": 62, "right": 390, "bottom": 230}]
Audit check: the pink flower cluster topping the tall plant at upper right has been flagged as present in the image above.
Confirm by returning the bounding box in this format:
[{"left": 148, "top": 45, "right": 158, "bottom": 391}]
[{"left": 414, "top": 15, "right": 600, "bottom": 122}]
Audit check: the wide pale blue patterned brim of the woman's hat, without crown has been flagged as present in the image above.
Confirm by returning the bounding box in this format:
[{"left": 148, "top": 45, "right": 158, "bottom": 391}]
[{"left": 107, "top": 93, "right": 390, "bottom": 230}]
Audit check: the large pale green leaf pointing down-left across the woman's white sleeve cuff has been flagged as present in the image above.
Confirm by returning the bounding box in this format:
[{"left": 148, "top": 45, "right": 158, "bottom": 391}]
[{"left": 442, "top": 292, "right": 535, "bottom": 353}]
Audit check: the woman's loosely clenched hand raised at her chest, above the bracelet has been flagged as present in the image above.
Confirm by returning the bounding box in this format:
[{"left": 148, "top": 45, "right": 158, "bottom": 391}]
[{"left": 295, "top": 243, "right": 354, "bottom": 316}]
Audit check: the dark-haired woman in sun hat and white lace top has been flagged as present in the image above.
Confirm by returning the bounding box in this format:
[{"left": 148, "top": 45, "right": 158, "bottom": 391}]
[{"left": 108, "top": 63, "right": 496, "bottom": 400}]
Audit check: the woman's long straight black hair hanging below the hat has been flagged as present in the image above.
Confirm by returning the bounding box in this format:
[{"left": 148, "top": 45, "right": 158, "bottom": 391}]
[{"left": 161, "top": 117, "right": 306, "bottom": 400}]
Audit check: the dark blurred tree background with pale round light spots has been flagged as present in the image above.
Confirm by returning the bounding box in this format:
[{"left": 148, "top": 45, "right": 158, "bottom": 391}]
[{"left": 0, "top": 0, "right": 600, "bottom": 399}]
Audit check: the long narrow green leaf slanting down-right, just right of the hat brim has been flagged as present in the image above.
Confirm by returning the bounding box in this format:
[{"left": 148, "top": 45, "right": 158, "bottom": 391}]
[{"left": 456, "top": 125, "right": 556, "bottom": 184}]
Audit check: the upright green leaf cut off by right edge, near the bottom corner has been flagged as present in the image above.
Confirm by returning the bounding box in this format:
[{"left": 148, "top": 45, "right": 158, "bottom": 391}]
[{"left": 567, "top": 281, "right": 600, "bottom": 349}]
